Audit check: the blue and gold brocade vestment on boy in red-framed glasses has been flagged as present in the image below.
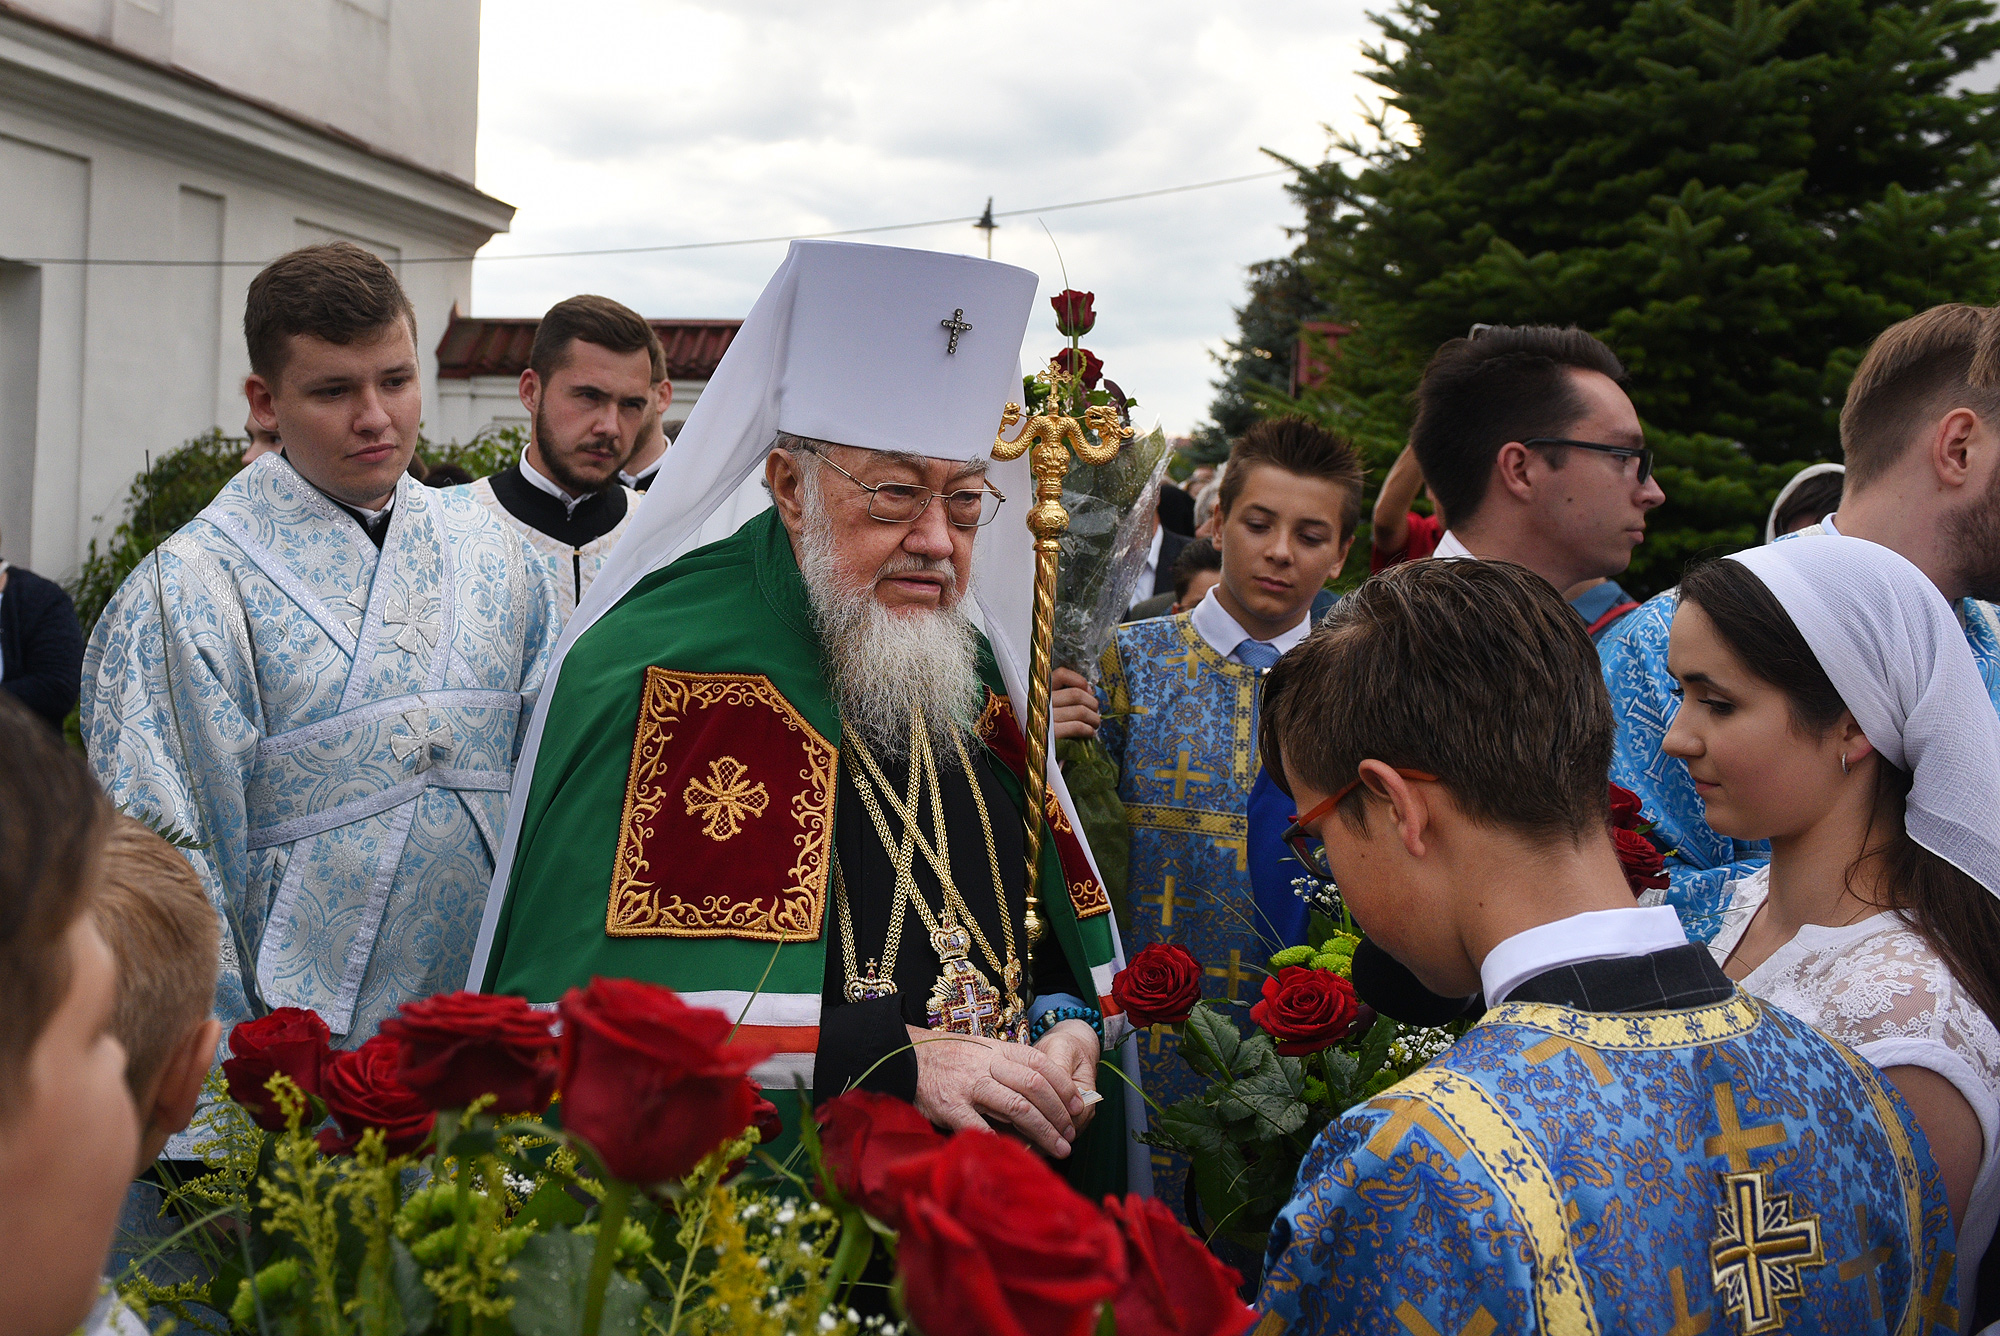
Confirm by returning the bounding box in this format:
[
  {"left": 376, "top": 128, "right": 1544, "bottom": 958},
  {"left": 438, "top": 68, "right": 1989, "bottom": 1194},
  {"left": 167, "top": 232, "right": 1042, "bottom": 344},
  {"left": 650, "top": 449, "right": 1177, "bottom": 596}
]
[{"left": 1254, "top": 992, "right": 1972, "bottom": 1336}]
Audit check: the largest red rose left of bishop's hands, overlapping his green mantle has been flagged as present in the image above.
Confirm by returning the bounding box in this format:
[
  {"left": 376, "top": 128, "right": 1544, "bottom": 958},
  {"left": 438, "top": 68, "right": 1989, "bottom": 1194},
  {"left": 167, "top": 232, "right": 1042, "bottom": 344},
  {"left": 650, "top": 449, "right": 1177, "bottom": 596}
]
[{"left": 556, "top": 978, "right": 770, "bottom": 1184}]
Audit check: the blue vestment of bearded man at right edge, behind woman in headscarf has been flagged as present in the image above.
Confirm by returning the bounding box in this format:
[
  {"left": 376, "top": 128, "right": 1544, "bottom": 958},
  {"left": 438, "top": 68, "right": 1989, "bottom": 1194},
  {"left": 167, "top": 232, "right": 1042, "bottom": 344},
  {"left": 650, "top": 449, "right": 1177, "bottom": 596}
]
[{"left": 1598, "top": 588, "right": 2000, "bottom": 942}]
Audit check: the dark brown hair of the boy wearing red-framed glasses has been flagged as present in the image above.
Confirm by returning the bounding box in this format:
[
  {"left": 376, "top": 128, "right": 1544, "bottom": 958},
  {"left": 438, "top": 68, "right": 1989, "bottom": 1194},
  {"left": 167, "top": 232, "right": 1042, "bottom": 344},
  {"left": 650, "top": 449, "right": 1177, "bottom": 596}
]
[{"left": 1258, "top": 560, "right": 1612, "bottom": 842}]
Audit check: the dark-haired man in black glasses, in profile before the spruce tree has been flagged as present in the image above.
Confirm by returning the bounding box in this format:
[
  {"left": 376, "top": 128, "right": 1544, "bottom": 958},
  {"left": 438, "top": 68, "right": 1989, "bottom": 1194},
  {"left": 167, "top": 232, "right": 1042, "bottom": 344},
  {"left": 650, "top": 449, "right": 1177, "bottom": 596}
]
[{"left": 1410, "top": 326, "right": 1666, "bottom": 638}]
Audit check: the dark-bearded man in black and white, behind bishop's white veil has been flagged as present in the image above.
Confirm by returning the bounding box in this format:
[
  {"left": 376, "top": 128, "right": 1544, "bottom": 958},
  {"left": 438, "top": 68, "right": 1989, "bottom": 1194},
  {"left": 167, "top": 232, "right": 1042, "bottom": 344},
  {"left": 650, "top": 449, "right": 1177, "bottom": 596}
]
[{"left": 468, "top": 294, "right": 666, "bottom": 622}]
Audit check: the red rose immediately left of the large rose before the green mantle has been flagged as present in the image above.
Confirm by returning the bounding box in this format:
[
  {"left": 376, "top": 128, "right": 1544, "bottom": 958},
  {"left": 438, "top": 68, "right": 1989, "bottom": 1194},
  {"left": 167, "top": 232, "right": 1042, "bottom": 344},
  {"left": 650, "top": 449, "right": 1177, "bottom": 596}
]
[{"left": 382, "top": 992, "right": 556, "bottom": 1114}]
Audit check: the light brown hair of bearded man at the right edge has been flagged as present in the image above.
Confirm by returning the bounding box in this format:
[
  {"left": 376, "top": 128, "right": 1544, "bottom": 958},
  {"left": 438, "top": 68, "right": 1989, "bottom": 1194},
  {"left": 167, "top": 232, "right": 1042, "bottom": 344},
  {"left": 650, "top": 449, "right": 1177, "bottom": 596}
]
[{"left": 1840, "top": 302, "right": 2000, "bottom": 488}]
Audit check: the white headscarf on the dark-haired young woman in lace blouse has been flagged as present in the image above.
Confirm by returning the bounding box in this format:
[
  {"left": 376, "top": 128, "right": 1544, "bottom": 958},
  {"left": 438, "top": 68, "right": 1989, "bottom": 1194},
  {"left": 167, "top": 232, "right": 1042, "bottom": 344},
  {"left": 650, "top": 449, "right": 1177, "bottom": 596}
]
[{"left": 1730, "top": 534, "right": 2000, "bottom": 896}]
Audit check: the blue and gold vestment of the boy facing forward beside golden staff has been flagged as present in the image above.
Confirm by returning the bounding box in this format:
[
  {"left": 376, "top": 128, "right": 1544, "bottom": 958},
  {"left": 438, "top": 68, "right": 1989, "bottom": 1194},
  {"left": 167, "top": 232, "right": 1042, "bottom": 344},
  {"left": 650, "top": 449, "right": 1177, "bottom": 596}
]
[{"left": 1100, "top": 614, "right": 1306, "bottom": 1212}]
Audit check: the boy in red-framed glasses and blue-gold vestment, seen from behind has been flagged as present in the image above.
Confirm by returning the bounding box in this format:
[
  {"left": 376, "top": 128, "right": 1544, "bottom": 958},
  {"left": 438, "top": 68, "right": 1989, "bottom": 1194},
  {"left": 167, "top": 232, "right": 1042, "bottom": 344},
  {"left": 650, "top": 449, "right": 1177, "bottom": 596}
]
[{"left": 1256, "top": 562, "right": 1958, "bottom": 1336}]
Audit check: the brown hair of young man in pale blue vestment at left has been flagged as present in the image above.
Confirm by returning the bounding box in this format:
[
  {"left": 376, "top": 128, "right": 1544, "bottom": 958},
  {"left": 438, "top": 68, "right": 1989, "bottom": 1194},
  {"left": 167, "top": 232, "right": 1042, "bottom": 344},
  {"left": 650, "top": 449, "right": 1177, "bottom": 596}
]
[{"left": 244, "top": 242, "right": 416, "bottom": 386}]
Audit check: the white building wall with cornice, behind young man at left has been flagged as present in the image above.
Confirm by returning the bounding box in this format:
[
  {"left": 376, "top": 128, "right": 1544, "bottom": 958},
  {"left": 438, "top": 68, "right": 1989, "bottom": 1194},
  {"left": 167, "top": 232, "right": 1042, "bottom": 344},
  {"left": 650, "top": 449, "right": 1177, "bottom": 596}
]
[{"left": 0, "top": 0, "right": 512, "bottom": 578}]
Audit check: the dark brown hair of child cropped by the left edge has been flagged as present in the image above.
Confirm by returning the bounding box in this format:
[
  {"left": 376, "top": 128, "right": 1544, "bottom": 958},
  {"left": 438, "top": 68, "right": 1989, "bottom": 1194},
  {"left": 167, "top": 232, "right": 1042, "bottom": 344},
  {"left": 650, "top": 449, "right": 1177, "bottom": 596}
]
[{"left": 0, "top": 692, "right": 110, "bottom": 1122}]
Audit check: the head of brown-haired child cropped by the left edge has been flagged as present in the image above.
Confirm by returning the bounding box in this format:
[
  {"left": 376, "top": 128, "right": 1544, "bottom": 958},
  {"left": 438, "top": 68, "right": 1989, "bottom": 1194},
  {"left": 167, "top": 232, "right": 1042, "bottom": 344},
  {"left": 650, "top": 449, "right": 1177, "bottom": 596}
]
[{"left": 0, "top": 692, "right": 138, "bottom": 1336}]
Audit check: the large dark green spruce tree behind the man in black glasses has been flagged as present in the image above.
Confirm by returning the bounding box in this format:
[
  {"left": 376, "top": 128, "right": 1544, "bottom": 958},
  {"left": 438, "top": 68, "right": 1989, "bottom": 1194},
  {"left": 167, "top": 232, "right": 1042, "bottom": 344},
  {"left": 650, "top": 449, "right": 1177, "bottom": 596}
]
[{"left": 1200, "top": 0, "right": 2000, "bottom": 592}]
